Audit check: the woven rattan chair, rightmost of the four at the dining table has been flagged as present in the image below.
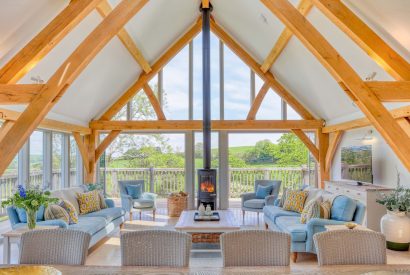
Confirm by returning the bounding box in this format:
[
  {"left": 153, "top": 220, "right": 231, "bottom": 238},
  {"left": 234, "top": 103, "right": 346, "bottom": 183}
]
[{"left": 313, "top": 229, "right": 386, "bottom": 265}]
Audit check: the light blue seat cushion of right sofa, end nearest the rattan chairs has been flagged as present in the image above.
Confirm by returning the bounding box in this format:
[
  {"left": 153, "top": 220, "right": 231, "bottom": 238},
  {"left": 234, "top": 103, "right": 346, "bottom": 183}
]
[{"left": 276, "top": 216, "right": 307, "bottom": 242}]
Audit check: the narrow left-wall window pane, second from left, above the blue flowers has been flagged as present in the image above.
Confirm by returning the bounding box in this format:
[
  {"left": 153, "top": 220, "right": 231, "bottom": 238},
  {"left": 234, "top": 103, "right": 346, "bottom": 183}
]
[{"left": 28, "top": 131, "right": 44, "bottom": 187}]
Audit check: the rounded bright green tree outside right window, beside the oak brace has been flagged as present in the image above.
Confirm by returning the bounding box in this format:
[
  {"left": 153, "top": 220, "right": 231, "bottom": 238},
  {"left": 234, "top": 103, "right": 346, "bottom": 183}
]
[{"left": 273, "top": 133, "right": 308, "bottom": 166}]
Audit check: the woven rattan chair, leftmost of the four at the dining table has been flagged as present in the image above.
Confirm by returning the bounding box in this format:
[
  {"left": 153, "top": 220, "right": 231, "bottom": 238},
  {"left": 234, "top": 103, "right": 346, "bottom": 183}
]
[{"left": 19, "top": 229, "right": 91, "bottom": 265}]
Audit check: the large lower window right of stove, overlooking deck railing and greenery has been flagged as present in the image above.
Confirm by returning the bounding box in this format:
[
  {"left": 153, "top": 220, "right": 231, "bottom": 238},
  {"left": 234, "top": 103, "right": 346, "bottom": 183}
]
[{"left": 229, "top": 133, "right": 310, "bottom": 207}]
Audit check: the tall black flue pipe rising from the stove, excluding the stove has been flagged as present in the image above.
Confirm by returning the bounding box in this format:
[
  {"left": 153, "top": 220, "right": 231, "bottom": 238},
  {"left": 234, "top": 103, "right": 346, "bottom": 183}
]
[{"left": 200, "top": 4, "right": 212, "bottom": 169}]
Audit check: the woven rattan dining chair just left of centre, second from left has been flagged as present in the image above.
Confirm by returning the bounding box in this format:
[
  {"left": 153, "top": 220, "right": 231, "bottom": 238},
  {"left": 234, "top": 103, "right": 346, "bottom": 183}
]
[{"left": 121, "top": 230, "right": 192, "bottom": 267}]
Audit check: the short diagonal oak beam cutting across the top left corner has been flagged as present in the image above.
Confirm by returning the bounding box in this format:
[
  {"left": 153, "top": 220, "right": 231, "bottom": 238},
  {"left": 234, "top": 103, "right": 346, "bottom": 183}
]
[{"left": 0, "top": 0, "right": 100, "bottom": 84}]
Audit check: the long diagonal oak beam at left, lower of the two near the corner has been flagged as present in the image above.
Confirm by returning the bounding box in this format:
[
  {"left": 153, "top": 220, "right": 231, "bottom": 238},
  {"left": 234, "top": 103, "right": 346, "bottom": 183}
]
[{"left": 0, "top": 0, "right": 148, "bottom": 177}]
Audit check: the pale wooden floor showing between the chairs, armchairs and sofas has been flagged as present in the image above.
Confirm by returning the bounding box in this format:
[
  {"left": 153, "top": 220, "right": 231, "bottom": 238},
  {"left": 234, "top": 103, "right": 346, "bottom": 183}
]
[{"left": 0, "top": 200, "right": 410, "bottom": 267}]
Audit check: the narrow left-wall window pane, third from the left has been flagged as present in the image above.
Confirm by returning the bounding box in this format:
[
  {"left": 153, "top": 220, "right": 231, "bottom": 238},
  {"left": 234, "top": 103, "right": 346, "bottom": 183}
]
[{"left": 50, "top": 133, "right": 63, "bottom": 190}]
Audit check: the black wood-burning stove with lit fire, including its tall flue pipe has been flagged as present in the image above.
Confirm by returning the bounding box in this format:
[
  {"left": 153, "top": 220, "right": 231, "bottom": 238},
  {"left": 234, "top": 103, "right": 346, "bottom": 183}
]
[{"left": 198, "top": 4, "right": 217, "bottom": 210}]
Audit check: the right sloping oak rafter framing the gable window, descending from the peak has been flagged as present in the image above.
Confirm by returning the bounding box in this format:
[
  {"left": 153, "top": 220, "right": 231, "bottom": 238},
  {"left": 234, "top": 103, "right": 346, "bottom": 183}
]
[{"left": 211, "top": 20, "right": 315, "bottom": 120}]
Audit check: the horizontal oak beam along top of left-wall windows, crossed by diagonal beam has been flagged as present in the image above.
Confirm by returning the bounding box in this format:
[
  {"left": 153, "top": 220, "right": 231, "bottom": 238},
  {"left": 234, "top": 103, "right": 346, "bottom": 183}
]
[{"left": 0, "top": 109, "right": 91, "bottom": 135}]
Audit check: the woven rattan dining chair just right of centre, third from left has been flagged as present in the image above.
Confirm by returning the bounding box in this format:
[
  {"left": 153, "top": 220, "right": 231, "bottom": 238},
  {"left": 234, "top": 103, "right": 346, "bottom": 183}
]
[{"left": 221, "top": 230, "right": 290, "bottom": 266}]
